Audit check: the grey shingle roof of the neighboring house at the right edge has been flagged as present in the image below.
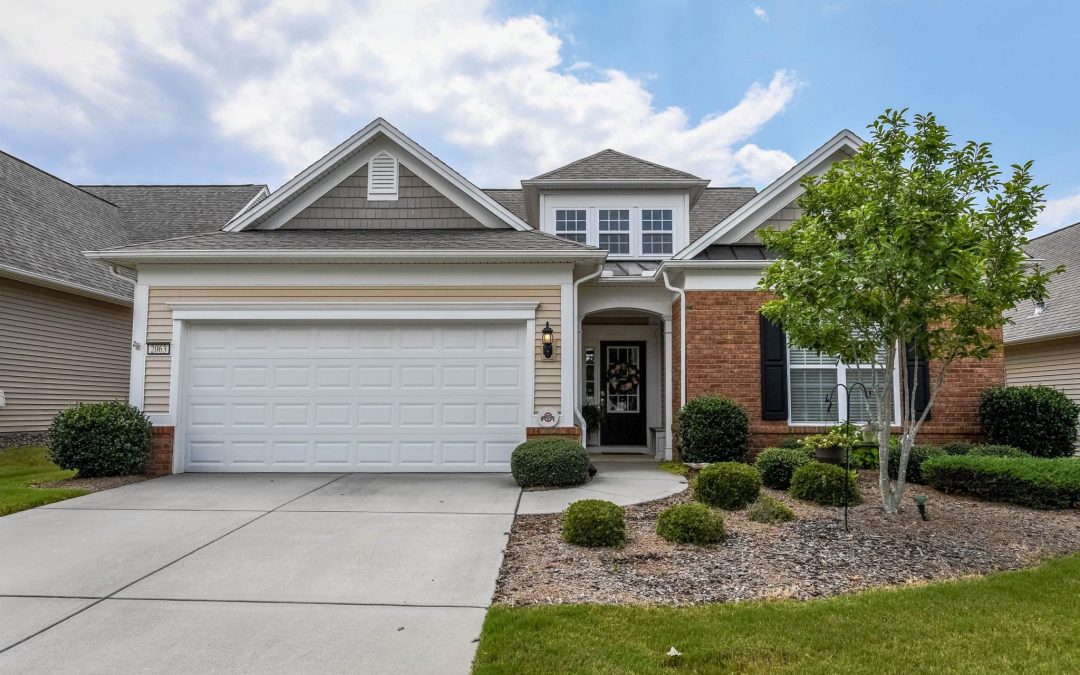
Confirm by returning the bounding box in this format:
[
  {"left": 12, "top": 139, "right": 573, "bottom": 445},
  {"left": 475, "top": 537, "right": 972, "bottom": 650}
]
[{"left": 1004, "top": 222, "right": 1080, "bottom": 345}]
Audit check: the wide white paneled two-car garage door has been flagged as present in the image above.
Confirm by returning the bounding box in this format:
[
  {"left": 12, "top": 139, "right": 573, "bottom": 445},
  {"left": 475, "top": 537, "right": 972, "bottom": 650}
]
[{"left": 180, "top": 322, "right": 527, "bottom": 471}]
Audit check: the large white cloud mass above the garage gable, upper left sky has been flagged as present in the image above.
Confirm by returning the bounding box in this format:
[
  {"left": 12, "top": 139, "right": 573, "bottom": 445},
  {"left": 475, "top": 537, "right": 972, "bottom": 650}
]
[{"left": 0, "top": 0, "right": 798, "bottom": 186}]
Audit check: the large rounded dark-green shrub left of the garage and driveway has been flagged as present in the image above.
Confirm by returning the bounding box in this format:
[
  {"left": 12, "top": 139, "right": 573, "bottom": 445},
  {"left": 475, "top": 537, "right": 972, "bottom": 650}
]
[{"left": 48, "top": 401, "right": 151, "bottom": 477}]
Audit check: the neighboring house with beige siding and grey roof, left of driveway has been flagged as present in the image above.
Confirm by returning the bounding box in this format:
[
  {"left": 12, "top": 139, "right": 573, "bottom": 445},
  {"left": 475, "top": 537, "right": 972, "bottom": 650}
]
[{"left": 0, "top": 152, "right": 266, "bottom": 447}]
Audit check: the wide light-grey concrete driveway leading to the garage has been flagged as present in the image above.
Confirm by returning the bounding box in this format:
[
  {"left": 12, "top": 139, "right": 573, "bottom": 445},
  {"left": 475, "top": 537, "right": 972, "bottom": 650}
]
[{"left": 0, "top": 474, "right": 519, "bottom": 673}]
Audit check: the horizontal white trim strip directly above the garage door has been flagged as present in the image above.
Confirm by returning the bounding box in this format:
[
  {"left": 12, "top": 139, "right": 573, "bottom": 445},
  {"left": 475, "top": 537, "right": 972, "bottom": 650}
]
[{"left": 167, "top": 302, "right": 539, "bottom": 321}]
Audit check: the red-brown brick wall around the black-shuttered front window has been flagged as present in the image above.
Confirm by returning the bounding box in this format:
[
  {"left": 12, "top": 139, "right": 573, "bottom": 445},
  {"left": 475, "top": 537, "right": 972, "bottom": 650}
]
[{"left": 672, "top": 291, "right": 1005, "bottom": 450}]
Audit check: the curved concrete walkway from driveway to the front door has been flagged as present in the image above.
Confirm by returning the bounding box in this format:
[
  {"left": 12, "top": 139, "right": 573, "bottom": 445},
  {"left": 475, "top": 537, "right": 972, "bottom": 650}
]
[{"left": 517, "top": 455, "right": 687, "bottom": 514}]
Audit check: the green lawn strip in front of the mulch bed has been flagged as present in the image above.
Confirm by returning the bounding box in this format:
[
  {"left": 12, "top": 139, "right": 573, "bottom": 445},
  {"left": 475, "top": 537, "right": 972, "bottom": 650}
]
[{"left": 475, "top": 555, "right": 1080, "bottom": 674}]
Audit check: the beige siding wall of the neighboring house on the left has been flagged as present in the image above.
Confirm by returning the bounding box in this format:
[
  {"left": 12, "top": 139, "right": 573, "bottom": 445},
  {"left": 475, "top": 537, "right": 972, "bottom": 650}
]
[{"left": 0, "top": 278, "right": 132, "bottom": 432}]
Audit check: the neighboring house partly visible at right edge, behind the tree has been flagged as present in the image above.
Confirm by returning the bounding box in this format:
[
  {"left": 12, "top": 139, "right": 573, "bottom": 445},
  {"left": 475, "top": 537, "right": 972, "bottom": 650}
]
[{"left": 1004, "top": 222, "right": 1080, "bottom": 403}]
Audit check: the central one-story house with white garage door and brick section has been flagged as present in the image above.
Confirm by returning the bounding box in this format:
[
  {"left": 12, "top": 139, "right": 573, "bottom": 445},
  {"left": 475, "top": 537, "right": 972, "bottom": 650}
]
[{"left": 79, "top": 119, "right": 1004, "bottom": 472}]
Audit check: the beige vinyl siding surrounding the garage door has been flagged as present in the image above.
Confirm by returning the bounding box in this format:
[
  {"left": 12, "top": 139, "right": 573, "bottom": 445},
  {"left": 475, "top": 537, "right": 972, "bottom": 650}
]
[{"left": 144, "top": 286, "right": 562, "bottom": 414}]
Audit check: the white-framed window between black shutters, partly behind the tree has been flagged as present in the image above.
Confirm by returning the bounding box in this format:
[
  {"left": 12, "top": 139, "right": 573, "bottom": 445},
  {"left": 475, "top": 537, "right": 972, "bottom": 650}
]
[{"left": 787, "top": 346, "right": 900, "bottom": 424}]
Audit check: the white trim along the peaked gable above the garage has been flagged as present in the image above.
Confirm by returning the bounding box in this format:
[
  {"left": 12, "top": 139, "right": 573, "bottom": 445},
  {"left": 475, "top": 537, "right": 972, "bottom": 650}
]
[{"left": 224, "top": 118, "right": 532, "bottom": 232}]
